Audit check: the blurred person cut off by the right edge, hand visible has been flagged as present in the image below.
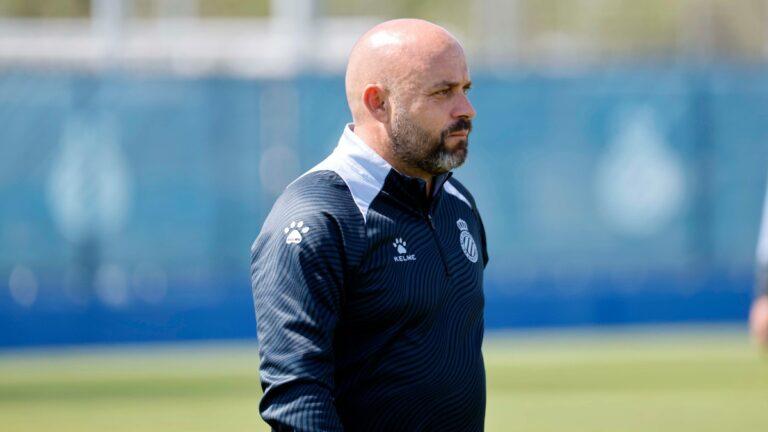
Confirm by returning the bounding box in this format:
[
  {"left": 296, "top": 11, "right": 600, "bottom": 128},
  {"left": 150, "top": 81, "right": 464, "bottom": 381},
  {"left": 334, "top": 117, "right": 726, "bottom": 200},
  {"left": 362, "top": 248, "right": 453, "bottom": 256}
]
[{"left": 749, "top": 181, "right": 768, "bottom": 348}]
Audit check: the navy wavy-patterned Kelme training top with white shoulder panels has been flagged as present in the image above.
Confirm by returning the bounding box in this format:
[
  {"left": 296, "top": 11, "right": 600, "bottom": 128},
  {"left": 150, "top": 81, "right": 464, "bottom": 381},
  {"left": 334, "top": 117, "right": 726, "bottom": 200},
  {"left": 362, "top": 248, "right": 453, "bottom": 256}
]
[{"left": 251, "top": 126, "right": 488, "bottom": 431}]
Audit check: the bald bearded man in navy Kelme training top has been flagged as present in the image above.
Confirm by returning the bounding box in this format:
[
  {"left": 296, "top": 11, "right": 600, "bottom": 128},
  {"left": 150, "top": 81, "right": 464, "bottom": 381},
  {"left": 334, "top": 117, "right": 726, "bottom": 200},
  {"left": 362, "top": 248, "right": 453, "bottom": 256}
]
[{"left": 251, "top": 19, "right": 488, "bottom": 432}]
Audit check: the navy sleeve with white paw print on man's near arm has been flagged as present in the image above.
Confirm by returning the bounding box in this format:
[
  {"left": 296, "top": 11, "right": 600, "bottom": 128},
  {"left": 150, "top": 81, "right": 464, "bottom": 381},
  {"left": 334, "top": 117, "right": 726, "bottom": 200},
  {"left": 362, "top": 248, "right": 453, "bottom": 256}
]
[{"left": 251, "top": 200, "right": 344, "bottom": 432}]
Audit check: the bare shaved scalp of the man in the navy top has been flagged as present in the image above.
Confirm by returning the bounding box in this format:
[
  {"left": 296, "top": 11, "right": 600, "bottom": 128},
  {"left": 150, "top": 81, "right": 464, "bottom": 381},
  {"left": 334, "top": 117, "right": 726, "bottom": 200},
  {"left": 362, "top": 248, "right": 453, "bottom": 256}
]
[{"left": 345, "top": 19, "right": 464, "bottom": 125}]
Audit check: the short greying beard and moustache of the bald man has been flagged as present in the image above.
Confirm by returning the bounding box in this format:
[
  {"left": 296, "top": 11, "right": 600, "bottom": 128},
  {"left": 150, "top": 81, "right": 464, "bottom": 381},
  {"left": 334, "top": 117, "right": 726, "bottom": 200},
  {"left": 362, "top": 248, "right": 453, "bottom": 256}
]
[{"left": 390, "top": 111, "right": 472, "bottom": 176}]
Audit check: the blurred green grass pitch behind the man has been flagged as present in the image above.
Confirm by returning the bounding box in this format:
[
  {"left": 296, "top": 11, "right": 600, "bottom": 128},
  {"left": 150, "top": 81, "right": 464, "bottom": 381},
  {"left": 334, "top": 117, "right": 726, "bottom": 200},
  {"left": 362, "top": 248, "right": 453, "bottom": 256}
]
[{"left": 0, "top": 327, "right": 768, "bottom": 432}]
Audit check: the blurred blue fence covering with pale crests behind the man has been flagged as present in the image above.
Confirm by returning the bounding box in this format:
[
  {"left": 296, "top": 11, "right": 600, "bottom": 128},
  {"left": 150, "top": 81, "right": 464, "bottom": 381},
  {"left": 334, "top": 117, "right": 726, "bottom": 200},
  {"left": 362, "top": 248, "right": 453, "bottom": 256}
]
[{"left": 0, "top": 67, "right": 768, "bottom": 346}]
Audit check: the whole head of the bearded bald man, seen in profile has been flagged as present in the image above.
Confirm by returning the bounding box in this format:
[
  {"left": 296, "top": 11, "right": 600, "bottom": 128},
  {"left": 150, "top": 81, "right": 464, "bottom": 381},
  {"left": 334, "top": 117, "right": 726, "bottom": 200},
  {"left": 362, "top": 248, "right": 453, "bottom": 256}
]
[{"left": 346, "top": 19, "right": 475, "bottom": 185}]
